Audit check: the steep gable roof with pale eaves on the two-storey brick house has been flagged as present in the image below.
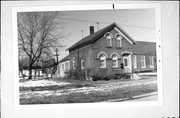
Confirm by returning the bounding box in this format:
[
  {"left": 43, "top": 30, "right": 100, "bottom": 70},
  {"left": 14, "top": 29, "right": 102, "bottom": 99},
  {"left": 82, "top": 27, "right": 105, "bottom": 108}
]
[{"left": 67, "top": 23, "right": 136, "bottom": 51}]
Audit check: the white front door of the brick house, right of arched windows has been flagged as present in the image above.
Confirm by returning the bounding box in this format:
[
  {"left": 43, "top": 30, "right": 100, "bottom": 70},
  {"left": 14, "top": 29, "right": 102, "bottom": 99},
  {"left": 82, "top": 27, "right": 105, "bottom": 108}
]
[{"left": 123, "top": 55, "right": 132, "bottom": 73}]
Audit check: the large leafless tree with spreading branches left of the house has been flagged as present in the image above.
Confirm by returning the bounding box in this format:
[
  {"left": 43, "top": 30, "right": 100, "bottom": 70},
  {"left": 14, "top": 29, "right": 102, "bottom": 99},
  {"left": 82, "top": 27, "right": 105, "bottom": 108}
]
[{"left": 18, "top": 12, "right": 65, "bottom": 79}]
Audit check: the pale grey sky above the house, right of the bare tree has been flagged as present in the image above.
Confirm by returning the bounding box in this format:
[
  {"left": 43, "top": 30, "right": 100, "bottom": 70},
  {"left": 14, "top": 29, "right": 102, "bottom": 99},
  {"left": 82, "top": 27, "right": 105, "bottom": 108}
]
[{"left": 55, "top": 9, "right": 155, "bottom": 58}]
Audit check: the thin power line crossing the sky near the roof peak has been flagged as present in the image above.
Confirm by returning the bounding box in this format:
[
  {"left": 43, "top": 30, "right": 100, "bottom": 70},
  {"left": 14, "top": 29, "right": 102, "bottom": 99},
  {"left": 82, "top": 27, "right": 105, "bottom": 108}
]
[{"left": 58, "top": 17, "right": 155, "bottom": 30}]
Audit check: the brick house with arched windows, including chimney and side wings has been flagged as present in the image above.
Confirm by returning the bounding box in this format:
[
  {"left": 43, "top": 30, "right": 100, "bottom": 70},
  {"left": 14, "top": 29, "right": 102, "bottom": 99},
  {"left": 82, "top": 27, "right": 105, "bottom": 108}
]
[{"left": 60, "top": 23, "right": 156, "bottom": 78}]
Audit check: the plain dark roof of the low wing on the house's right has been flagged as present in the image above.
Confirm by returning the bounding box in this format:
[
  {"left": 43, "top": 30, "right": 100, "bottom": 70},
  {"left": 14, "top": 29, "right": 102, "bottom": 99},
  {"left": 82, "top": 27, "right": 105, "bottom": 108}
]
[{"left": 133, "top": 41, "right": 156, "bottom": 56}]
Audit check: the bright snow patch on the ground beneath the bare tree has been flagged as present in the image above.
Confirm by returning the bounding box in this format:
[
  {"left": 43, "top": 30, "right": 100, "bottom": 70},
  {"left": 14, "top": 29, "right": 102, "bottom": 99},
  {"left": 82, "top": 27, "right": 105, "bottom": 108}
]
[{"left": 19, "top": 80, "right": 71, "bottom": 87}]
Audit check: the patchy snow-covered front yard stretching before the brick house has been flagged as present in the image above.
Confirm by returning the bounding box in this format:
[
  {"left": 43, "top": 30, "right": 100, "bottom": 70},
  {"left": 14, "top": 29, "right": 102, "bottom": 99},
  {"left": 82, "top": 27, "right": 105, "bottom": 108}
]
[{"left": 20, "top": 79, "right": 157, "bottom": 104}]
